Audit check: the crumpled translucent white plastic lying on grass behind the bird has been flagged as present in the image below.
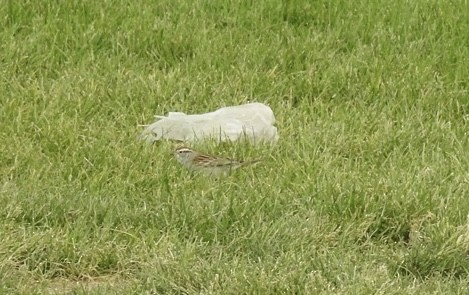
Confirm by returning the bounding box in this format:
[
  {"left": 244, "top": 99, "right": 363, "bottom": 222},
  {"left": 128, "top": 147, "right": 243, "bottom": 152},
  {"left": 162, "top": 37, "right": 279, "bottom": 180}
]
[{"left": 141, "top": 102, "right": 278, "bottom": 143}]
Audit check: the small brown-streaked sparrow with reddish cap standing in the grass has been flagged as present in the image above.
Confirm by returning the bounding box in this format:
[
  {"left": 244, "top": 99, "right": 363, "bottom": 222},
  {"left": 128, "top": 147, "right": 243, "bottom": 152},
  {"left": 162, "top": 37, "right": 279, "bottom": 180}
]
[{"left": 175, "top": 146, "right": 260, "bottom": 177}]
